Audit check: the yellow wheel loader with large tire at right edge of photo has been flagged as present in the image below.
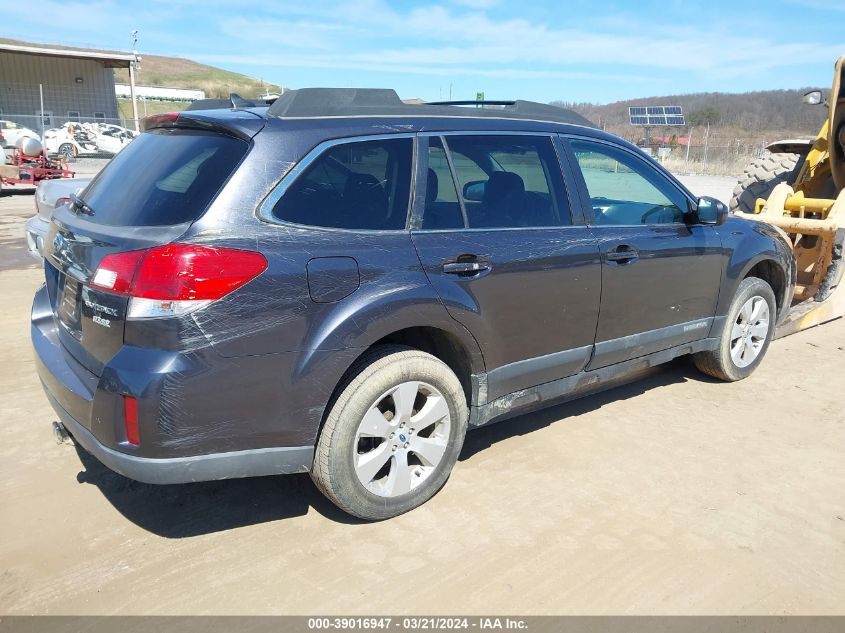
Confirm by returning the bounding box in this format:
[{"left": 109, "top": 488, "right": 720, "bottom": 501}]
[{"left": 731, "top": 56, "right": 845, "bottom": 338}]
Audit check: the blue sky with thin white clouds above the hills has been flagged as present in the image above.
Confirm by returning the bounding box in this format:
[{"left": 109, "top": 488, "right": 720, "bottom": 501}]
[{"left": 0, "top": 0, "right": 845, "bottom": 103}]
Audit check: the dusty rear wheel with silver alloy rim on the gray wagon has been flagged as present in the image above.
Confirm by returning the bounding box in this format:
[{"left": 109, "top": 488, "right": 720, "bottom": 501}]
[{"left": 311, "top": 345, "right": 469, "bottom": 521}]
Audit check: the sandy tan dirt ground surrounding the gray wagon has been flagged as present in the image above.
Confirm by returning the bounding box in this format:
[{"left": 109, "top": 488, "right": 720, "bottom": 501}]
[{"left": 0, "top": 177, "right": 845, "bottom": 614}]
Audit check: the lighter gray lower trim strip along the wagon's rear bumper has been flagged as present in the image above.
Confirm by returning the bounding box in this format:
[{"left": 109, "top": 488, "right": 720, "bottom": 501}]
[{"left": 47, "top": 391, "right": 314, "bottom": 484}]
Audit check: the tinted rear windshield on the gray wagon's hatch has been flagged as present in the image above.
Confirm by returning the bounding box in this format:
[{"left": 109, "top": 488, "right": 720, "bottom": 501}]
[{"left": 82, "top": 130, "right": 249, "bottom": 226}]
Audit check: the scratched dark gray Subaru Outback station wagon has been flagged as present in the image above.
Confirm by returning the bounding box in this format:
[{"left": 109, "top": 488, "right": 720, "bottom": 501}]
[{"left": 32, "top": 89, "right": 796, "bottom": 519}]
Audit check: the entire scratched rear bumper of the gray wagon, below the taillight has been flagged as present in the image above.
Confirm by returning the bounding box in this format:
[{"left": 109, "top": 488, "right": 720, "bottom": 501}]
[{"left": 31, "top": 288, "right": 314, "bottom": 484}]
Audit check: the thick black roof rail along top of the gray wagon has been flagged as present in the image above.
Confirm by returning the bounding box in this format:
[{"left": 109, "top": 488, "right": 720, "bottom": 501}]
[{"left": 267, "top": 88, "right": 595, "bottom": 127}]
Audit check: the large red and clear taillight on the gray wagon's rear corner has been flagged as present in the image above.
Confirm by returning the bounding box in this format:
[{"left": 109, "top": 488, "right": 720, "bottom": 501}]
[{"left": 91, "top": 244, "right": 267, "bottom": 319}]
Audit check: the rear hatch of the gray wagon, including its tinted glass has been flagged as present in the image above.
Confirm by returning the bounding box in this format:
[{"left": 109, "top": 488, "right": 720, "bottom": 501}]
[{"left": 44, "top": 126, "right": 249, "bottom": 375}]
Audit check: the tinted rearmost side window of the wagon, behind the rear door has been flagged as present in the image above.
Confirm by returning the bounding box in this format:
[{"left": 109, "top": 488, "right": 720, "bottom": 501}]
[{"left": 273, "top": 138, "right": 413, "bottom": 230}]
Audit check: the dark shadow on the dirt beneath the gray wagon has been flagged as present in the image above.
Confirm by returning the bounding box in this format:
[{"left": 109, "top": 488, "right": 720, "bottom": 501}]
[{"left": 76, "top": 359, "right": 712, "bottom": 539}]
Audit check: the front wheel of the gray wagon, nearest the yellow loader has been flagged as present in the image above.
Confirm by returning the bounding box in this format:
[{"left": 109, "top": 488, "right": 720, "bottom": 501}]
[{"left": 693, "top": 277, "right": 777, "bottom": 382}]
